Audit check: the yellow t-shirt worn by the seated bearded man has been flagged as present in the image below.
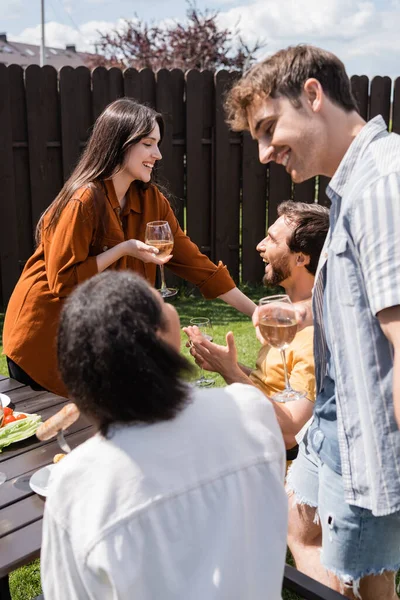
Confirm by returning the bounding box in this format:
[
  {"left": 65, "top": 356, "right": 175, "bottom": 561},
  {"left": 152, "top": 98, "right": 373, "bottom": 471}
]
[{"left": 250, "top": 326, "right": 315, "bottom": 402}]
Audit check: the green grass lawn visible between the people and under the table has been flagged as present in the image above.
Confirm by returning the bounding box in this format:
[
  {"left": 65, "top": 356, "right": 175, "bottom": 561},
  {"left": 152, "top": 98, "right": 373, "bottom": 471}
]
[{"left": 0, "top": 287, "right": 299, "bottom": 600}]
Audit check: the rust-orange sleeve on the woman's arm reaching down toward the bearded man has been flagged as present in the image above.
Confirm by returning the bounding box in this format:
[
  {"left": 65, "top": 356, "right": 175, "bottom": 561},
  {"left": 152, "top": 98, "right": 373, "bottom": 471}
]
[{"left": 159, "top": 193, "right": 236, "bottom": 299}]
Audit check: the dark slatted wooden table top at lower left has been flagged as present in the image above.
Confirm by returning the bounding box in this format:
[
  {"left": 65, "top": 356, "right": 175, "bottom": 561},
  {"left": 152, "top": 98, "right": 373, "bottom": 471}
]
[{"left": 0, "top": 375, "right": 94, "bottom": 578}]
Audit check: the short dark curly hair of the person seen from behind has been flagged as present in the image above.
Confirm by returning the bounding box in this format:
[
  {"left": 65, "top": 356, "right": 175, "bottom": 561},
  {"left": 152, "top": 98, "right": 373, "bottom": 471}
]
[{"left": 57, "top": 271, "right": 192, "bottom": 436}]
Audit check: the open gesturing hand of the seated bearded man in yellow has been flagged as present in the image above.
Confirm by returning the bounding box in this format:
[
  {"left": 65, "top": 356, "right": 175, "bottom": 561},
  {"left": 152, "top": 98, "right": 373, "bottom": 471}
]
[{"left": 183, "top": 325, "right": 238, "bottom": 377}]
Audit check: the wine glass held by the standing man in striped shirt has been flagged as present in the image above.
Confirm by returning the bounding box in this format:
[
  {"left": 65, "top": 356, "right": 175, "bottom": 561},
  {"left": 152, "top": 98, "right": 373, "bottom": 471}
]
[{"left": 258, "top": 294, "right": 305, "bottom": 402}]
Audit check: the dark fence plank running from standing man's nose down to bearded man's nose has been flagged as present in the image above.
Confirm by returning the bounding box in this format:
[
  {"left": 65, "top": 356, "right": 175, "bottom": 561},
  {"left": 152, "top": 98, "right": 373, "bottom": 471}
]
[{"left": 242, "top": 132, "right": 268, "bottom": 283}]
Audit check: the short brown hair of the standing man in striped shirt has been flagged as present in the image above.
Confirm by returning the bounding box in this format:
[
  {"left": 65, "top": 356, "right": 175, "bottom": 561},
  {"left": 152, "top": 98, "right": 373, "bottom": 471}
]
[{"left": 225, "top": 44, "right": 358, "bottom": 131}]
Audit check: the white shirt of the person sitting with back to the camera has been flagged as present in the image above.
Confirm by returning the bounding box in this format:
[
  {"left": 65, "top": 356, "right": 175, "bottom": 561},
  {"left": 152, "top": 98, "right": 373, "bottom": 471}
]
[{"left": 41, "top": 384, "right": 287, "bottom": 600}]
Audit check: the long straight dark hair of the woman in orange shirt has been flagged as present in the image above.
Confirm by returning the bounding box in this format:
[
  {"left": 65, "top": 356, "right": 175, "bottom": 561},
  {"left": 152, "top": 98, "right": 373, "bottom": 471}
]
[{"left": 36, "top": 98, "right": 164, "bottom": 244}]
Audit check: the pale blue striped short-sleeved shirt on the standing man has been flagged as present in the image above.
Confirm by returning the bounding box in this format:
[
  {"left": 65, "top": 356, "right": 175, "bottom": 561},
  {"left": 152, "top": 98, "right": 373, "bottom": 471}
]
[{"left": 313, "top": 116, "right": 400, "bottom": 516}]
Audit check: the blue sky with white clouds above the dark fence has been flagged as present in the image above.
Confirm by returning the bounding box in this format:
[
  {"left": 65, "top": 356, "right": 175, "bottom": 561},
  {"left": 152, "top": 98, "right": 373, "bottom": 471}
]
[{"left": 0, "top": 0, "right": 400, "bottom": 78}]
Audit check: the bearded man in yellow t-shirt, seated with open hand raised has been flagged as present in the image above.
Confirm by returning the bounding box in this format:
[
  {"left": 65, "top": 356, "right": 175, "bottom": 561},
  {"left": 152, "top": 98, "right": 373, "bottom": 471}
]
[{"left": 184, "top": 201, "right": 329, "bottom": 448}]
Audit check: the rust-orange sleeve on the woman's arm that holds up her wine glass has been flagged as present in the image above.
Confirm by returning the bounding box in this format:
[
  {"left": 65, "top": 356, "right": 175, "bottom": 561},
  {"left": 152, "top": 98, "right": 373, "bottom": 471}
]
[{"left": 43, "top": 200, "right": 98, "bottom": 298}]
